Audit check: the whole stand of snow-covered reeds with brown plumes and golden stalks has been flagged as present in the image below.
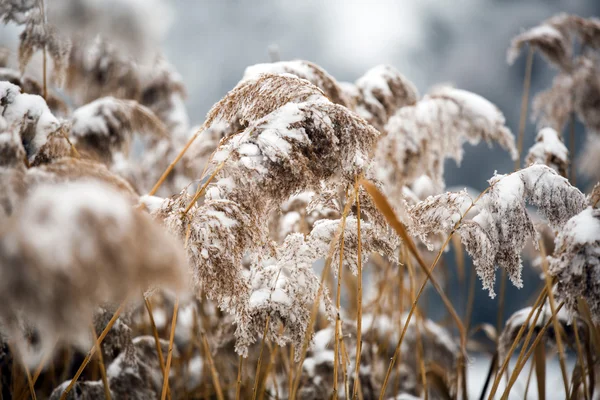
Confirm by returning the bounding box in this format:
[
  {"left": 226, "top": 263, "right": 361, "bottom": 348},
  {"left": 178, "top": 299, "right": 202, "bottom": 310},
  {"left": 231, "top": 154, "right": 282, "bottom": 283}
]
[{"left": 0, "top": 0, "right": 600, "bottom": 400}]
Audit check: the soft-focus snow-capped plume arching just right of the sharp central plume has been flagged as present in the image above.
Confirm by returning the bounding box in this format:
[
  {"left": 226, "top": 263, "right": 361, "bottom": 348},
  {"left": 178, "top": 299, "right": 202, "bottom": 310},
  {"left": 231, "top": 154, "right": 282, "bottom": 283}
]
[{"left": 375, "top": 88, "right": 517, "bottom": 195}]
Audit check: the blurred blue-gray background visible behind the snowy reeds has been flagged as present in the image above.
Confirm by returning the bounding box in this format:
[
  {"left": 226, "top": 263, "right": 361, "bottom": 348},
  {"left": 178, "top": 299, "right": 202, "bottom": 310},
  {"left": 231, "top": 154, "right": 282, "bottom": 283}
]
[{"left": 165, "top": 0, "right": 600, "bottom": 323}]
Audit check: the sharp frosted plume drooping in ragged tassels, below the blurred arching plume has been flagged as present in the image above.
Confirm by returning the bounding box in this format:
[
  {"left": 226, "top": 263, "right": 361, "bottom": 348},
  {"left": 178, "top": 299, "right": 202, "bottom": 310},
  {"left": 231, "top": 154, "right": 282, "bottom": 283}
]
[{"left": 458, "top": 164, "right": 586, "bottom": 297}]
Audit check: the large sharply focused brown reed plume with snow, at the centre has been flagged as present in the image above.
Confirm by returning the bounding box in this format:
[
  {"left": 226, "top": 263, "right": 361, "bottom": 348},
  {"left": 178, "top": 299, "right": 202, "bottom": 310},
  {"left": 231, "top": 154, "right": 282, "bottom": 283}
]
[{"left": 152, "top": 75, "right": 378, "bottom": 351}]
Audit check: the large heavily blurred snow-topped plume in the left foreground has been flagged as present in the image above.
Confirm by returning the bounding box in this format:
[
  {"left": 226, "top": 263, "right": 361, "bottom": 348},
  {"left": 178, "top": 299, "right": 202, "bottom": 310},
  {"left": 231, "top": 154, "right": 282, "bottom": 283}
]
[{"left": 0, "top": 183, "right": 185, "bottom": 364}]
